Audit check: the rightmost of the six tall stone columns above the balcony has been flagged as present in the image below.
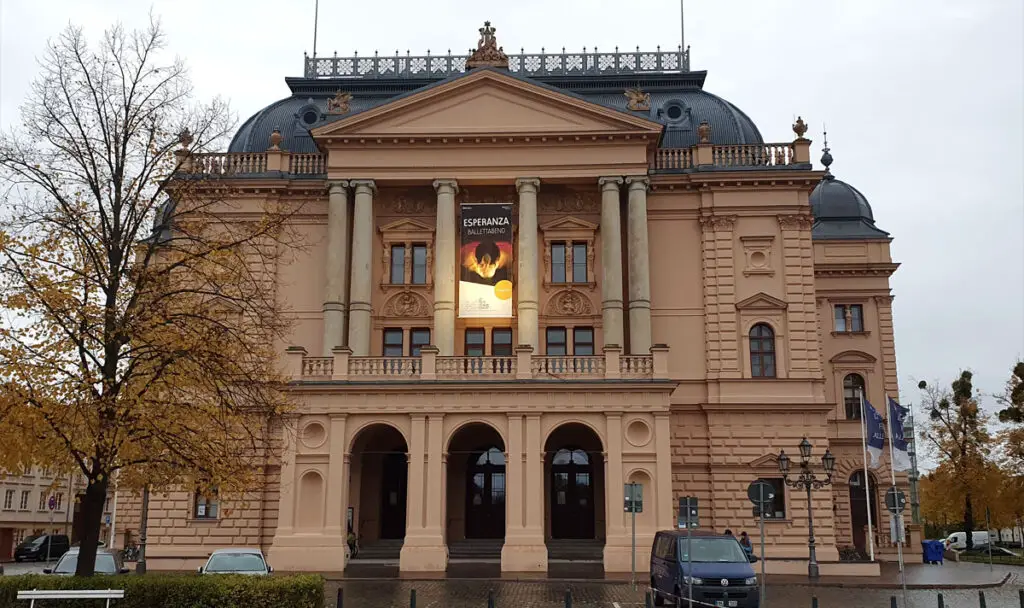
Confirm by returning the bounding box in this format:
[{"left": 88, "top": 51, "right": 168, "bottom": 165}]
[{"left": 626, "top": 176, "right": 651, "bottom": 354}]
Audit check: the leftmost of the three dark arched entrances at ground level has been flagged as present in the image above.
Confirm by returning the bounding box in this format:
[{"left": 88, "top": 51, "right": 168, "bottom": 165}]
[{"left": 349, "top": 424, "right": 409, "bottom": 540}]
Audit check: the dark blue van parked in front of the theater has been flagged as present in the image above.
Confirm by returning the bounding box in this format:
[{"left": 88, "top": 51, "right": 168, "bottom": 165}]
[{"left": 650, "top": 530, "right": 760, "bottom": 608}]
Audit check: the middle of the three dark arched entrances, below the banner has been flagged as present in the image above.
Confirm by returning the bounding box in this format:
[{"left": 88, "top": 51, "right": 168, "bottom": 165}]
[{"left": 447, "top": 423, "right": 506, "bottom": 546}]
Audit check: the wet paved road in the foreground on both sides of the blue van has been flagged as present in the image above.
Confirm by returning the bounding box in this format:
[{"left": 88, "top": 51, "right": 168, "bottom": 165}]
[{"left": 327, "top": 580, "right": 1024, "bottom": 608}]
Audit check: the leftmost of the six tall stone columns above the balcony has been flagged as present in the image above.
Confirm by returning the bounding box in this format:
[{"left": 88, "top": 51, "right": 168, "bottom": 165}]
[{"left": 324, "top": 181, "right": 348, "bottom": 357}]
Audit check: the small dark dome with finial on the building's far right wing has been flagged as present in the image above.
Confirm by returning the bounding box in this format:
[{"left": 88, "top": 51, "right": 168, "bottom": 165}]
[{"left": 810, "top": 149, "right": 889, "bottom": 241}]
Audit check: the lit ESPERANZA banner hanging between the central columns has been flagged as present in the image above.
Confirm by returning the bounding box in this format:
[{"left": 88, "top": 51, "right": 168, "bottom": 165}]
[{"left": 459, "top": 204, "right": 512, "bottom": 318}]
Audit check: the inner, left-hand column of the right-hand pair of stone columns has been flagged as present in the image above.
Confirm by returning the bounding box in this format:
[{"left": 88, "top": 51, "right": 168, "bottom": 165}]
[{"left": 597, "top": 177, "right": 625, "bottom": 346}]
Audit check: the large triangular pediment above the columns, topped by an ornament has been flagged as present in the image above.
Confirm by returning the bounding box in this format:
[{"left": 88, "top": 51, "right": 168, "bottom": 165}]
[{"left": 313, "top": 69, "right": 662, "bottom": 137}]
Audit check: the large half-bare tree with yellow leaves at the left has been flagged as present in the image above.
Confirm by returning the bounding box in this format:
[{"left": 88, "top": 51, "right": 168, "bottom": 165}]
[{"left": 0, "top": 23, "right": 294, "bottom": 575}]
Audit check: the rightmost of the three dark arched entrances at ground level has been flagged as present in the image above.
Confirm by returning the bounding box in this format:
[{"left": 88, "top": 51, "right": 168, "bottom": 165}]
[{"left": 544, "top": 423, "right": 605, "bottom": 539}]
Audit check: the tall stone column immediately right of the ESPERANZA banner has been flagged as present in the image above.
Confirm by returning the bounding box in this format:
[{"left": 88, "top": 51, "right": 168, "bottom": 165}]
[{"left": 515, "top": 177, "right": 541, "bottom": 352}]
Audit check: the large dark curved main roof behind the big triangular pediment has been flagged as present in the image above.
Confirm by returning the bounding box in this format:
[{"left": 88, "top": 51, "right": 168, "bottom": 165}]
[{"left": 228, "top": 72, "right": 764, "bottom": 154}]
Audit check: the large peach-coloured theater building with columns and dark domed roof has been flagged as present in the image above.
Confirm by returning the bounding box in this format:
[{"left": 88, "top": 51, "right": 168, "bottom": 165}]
[{"left": 118, "top": 25, "right": 903, "bottom": 573}]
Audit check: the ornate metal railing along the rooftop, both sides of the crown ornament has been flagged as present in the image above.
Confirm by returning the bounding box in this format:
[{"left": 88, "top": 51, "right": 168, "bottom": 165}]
[{"left": 303, "top": 47, "right": 690, "bottom": 80}]
